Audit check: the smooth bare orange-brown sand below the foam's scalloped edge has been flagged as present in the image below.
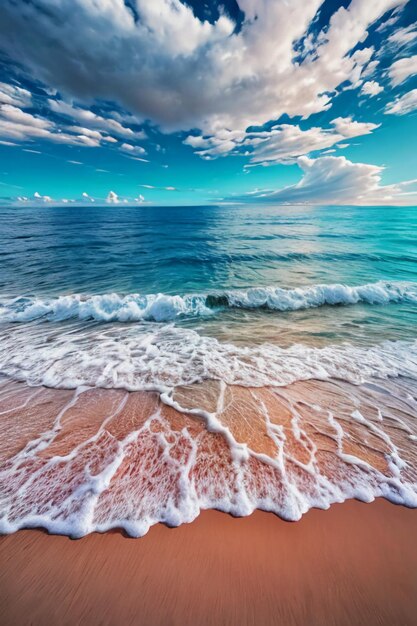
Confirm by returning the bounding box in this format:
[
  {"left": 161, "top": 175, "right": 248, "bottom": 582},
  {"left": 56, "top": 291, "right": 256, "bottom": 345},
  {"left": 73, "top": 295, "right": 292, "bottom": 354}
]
[{"left": 0, "top": 499, "right": 417, "bottom": 626}]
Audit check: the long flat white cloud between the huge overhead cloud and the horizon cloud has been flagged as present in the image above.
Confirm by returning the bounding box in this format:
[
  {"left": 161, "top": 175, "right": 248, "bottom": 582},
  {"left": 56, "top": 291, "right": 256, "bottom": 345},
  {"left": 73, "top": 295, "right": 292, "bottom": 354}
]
[{"left": 184, "top": 117, "right": 379, "bottom": 165}]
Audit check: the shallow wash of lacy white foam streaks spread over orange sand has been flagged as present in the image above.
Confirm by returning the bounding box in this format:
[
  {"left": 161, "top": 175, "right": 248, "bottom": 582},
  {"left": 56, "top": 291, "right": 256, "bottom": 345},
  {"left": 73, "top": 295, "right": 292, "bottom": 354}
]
[{"left": 0, "top": 379, "right": 417, "bottom": 537}]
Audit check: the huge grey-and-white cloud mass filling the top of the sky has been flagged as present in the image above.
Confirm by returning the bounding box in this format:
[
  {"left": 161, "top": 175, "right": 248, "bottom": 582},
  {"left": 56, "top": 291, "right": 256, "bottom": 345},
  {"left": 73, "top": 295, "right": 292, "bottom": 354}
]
[{"left": 0, "top": 0, "right": 406, "bottom": 136}]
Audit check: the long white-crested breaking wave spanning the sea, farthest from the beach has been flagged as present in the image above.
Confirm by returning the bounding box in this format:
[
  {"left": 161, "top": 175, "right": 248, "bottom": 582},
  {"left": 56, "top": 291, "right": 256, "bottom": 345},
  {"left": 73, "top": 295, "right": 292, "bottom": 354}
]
[{"left": 0, "top": 281, "right": 417, "bottom": 322}]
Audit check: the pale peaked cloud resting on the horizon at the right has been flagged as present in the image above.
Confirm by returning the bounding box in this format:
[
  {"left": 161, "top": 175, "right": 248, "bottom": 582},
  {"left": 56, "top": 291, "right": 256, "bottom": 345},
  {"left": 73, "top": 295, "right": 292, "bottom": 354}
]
[{"left": 242, "top": 156, "right": 417, "bottom": 205}]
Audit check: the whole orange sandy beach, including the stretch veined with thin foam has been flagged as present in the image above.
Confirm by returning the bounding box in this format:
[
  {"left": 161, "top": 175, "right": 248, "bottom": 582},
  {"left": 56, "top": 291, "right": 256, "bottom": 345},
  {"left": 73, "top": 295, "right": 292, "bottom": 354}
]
[{"left": 0, "top": 379, "right": 417, "bottom": 626}]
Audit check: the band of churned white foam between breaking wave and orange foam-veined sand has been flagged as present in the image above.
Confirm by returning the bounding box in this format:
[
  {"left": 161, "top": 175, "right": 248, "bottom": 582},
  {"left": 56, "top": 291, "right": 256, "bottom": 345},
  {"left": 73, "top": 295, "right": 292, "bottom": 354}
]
[{"left": 0, "top": 324, "right": 417, "bottom": 390}]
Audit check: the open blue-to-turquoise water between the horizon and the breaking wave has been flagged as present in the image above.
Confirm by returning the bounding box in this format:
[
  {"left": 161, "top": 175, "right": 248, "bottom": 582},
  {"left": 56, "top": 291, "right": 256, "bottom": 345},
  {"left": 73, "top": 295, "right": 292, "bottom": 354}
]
[{"left": 0, "top": 206, "right": 417, "bottom": 296}]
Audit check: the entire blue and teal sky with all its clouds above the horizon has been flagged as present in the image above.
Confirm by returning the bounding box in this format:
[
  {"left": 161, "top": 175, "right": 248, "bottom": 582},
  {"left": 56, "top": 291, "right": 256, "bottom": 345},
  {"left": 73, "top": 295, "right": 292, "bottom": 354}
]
[{"left": 0, "top": 0, "right": 417, "bottom": 206}]
